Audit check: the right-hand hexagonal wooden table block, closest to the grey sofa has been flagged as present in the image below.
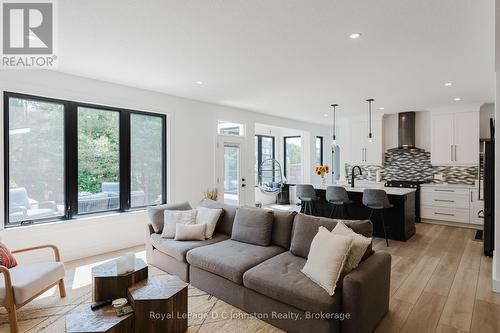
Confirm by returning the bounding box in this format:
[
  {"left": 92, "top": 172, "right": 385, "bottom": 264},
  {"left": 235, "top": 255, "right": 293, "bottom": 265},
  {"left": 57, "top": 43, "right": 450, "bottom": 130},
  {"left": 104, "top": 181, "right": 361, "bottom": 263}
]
[{"left": 128, "top": 275, "right": 188, "bottom": 333}]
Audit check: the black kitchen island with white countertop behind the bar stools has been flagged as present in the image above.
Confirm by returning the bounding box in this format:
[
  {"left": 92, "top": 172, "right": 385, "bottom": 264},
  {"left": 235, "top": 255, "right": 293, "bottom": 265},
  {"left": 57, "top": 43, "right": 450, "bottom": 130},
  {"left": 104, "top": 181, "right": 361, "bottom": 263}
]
[{"left": 301, "top": 183, "right": 416, "bottom": 241}]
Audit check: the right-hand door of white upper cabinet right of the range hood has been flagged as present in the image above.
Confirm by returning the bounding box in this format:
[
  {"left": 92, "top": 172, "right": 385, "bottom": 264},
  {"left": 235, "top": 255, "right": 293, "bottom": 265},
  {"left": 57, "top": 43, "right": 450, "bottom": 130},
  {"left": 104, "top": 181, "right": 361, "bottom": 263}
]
[{"left": 453, "top": 112, "right": 479, "bottom": 165}]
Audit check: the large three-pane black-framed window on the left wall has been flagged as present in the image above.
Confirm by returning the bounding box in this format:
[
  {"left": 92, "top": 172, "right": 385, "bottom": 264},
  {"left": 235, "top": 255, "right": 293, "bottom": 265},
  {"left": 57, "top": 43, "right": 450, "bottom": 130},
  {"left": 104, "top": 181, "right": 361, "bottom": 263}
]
[{"left": 4, "top": 92, "right": 167, "bottom": 227}]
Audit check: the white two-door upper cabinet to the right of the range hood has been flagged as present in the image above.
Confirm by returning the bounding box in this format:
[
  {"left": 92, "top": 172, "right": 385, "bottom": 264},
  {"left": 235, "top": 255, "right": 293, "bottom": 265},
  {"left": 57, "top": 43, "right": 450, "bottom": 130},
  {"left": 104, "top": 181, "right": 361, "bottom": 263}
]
[{"left": 431, "top": 112, "right": 479, "bottom": 166}]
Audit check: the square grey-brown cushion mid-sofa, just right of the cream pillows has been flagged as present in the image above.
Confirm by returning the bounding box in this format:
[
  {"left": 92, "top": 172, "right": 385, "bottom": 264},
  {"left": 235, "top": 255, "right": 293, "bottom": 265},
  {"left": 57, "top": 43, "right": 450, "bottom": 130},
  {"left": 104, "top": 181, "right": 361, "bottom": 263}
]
[{"left": 231, "top": 207, "right": 274, "bottom": 246}]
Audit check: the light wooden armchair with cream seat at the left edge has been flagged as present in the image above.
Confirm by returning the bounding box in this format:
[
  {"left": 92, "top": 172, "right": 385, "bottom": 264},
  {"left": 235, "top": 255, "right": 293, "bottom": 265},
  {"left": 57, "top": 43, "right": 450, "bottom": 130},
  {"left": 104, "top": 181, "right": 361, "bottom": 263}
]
[{"left": 0, "top": 245, "right": 66, "bottom": 333}]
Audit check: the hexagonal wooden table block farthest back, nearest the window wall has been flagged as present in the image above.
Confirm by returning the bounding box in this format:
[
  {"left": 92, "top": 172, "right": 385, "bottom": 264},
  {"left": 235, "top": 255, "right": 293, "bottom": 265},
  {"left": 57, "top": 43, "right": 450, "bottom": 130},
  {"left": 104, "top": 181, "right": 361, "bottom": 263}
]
[{"left": 92, "top": 258, "right": 148, "bottom": 302}]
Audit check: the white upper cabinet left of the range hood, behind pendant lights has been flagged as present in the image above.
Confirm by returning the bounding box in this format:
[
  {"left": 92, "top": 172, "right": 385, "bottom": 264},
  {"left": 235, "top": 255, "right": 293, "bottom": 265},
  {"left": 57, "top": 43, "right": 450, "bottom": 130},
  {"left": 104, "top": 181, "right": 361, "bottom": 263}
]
[{"left": 349, "top": 120, "right": 383, "bottom": 165}]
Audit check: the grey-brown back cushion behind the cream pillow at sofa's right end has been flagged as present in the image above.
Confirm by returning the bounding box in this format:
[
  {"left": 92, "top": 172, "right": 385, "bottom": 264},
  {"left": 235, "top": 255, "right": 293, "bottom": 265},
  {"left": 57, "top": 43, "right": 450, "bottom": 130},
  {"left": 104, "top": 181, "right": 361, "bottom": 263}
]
[{"left": 290, "top": 213, "right": 373, "bottom": 259}]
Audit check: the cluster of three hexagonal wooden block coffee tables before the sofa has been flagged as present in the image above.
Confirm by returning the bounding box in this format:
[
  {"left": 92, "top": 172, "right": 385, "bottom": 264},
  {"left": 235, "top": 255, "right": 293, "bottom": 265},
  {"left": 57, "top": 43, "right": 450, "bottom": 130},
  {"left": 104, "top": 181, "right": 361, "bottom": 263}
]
[{"left": 66, "top": 259, "right": 188, "bottom": 333}]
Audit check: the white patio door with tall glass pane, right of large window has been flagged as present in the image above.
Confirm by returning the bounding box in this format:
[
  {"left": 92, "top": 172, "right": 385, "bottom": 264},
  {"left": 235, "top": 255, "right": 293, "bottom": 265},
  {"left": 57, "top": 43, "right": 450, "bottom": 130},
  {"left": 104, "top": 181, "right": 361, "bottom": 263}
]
[{"left": 217, "top": 136, "right": 246, "bottom": 206}]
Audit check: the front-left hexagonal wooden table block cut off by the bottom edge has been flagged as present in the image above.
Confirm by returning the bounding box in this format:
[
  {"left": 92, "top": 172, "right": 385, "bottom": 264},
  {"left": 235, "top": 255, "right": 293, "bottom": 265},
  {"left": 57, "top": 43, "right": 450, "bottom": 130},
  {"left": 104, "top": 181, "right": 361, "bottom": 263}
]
[{"left": 66, "top": 305, "right": 134, "bottom": 333}]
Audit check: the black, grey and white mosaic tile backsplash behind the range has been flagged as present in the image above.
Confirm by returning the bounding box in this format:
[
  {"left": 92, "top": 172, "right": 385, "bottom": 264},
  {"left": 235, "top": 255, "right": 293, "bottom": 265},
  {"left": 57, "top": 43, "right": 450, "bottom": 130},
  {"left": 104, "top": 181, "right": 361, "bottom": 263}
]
[{"left": 345, "top": 151, "right": 478, "bottom": 185}]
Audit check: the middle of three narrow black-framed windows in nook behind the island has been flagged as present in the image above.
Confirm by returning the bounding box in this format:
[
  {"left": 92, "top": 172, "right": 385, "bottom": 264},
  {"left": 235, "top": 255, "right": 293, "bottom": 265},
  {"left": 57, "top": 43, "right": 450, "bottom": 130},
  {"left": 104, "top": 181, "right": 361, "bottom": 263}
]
[{"left": 283, "top": 136, "right": 303, "bottom": 184}]
